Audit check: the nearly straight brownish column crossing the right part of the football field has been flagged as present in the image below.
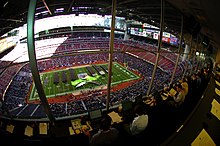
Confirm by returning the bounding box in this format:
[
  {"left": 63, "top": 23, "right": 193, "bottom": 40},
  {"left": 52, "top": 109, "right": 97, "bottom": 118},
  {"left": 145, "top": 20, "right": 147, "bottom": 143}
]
[{"left": 106, "top": 0, "right": 116, "bottom": 111}]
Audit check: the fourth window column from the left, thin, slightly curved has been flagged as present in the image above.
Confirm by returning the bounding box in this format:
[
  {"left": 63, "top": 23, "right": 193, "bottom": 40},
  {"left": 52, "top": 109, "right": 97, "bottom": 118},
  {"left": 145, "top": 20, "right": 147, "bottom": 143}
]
[{"left": 170, "top": 16, "right": 183, "bottom": 85}]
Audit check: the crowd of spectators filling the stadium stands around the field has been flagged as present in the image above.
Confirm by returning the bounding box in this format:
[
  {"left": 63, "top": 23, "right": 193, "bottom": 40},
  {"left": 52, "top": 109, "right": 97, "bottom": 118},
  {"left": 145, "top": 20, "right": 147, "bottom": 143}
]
[{"left": 1, "top": 32, "right": 196, "bottom": 120}]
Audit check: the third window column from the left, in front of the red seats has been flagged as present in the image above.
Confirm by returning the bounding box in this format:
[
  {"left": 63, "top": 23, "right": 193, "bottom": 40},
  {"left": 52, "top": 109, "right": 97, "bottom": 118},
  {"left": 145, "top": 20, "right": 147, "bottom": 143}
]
[{"left": 147, "top": 0, "right": 164, "bottom": 96}]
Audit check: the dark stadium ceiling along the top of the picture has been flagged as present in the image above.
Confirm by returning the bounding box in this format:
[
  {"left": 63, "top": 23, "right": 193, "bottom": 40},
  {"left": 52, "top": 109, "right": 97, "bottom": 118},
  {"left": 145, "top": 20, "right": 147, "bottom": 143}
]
[{"left": 0, "top": 0, "right": 220, "bottom": 52}]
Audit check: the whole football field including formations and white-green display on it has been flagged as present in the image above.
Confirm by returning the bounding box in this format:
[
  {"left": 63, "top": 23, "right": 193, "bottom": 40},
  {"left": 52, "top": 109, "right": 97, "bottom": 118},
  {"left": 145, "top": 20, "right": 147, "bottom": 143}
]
[{"left": 29, "top": 62, "right": 140, "bottom": 101}]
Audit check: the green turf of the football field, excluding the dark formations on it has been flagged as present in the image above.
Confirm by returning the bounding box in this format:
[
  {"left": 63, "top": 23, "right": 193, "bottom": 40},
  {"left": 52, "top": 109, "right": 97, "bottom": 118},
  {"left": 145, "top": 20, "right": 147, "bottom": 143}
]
[{"left": 29, "top": 62, "right": 139, "bottom": 100}]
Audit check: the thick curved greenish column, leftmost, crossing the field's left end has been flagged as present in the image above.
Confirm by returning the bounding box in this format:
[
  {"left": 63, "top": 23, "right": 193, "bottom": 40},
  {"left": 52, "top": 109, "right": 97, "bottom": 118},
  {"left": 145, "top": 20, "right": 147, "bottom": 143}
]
[{"left": 27, "top": 0, "right": 55, "bottom": 123}]
